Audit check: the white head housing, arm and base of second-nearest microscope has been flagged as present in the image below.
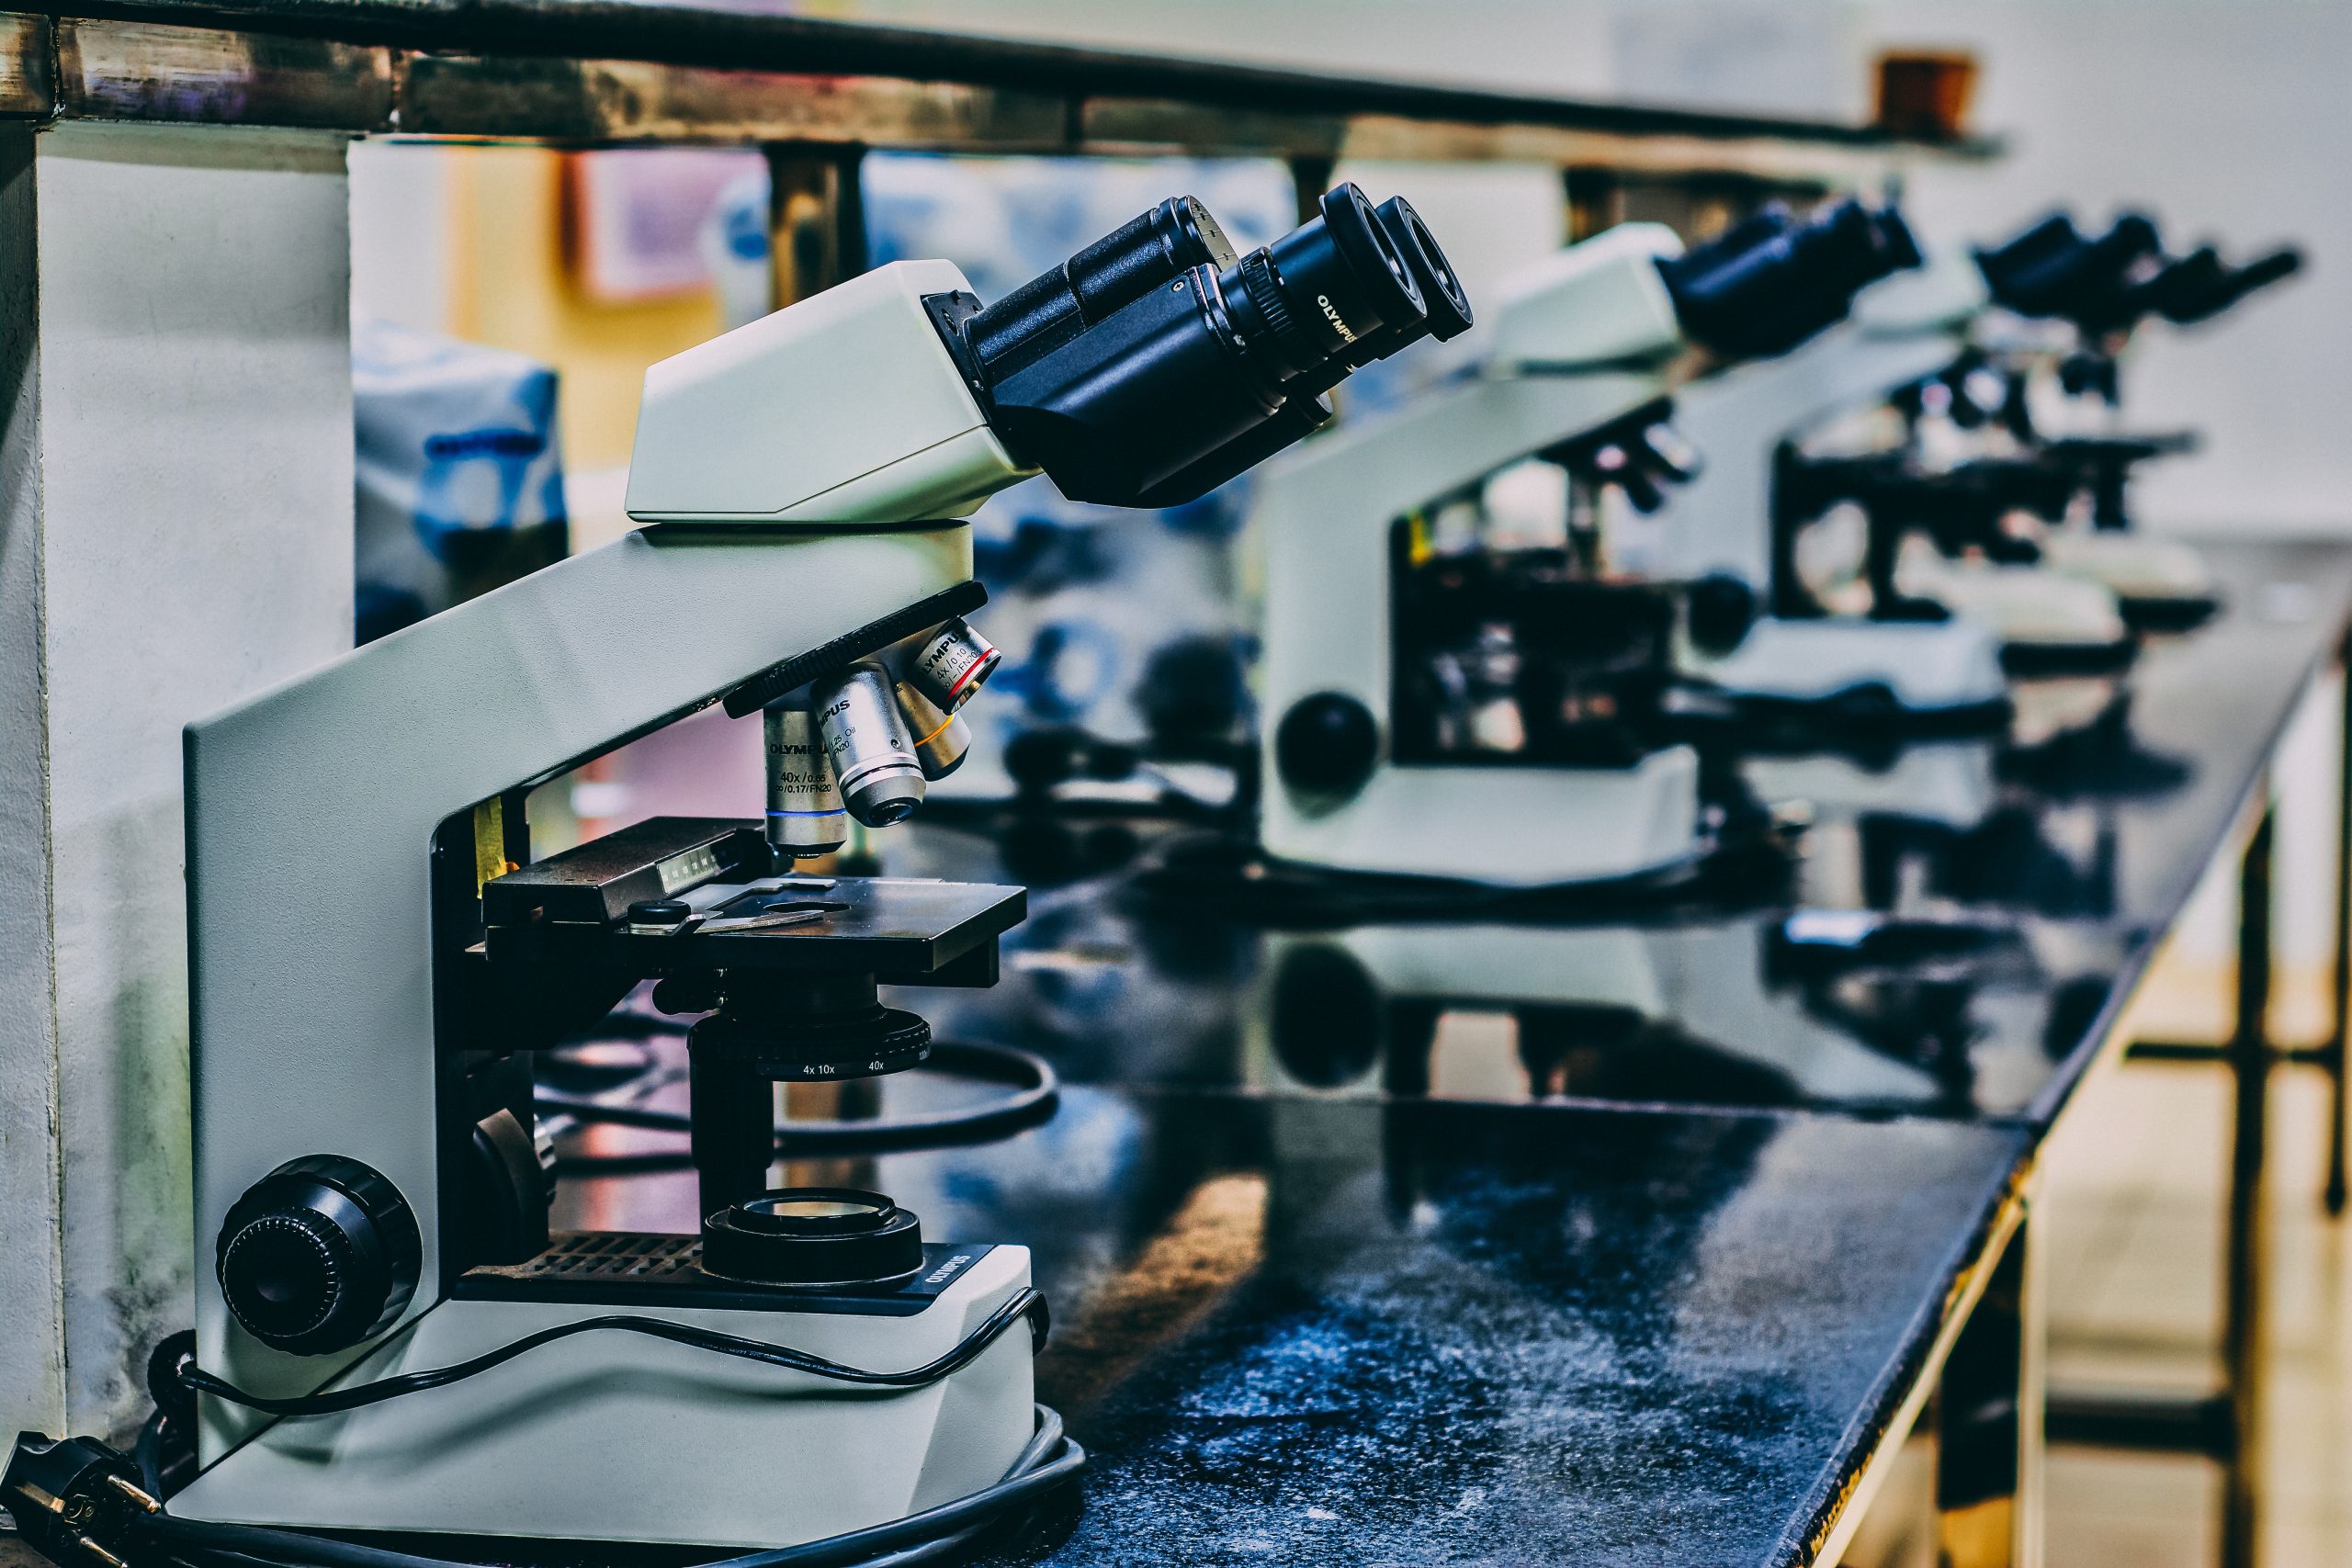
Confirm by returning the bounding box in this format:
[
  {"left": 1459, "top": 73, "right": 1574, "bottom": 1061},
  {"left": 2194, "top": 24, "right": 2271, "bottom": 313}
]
[{"left": 1251, "top": 223, "right": 1701, "bottom": 886}]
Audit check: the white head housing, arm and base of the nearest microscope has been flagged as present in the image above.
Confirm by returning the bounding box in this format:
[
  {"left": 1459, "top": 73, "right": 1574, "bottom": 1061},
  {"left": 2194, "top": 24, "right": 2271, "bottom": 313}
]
[{"left": 172, "top": 261, "right": 1030, "bottom": 1547}]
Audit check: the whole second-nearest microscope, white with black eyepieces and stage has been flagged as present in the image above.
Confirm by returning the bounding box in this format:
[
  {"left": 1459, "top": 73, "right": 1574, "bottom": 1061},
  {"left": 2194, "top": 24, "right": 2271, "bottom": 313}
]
[{"left": 1251, "top": 200, "right": 1917, "bottom": 886}]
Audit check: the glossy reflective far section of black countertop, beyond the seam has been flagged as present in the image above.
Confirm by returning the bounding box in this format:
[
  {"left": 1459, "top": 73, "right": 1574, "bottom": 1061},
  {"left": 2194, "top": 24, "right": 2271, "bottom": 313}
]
[{"left": 865, "top": 543, "right": 2352, "bottom": 1122}]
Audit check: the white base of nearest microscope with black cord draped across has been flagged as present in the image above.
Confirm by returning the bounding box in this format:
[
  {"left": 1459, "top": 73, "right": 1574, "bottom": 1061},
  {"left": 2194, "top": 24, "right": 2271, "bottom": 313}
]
[{"left": 172, "top": 1246, "right": 1033, "bottom": 1547}]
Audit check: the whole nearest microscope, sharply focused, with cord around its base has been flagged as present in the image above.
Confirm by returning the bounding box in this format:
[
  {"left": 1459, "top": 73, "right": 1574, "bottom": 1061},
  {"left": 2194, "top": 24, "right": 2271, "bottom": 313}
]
[{"left": 0, "top": 184, "right": 1465, "bottom": 1565}]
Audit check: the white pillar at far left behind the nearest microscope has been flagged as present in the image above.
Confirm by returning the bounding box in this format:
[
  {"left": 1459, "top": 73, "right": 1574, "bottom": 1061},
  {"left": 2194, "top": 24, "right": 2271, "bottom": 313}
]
[{"left": 0, "top": 122, "right": 353, "bottom": 1434}]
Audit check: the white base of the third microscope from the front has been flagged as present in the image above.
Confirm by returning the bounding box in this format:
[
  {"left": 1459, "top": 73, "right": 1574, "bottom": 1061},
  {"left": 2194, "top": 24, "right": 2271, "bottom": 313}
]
[{"left": 1691, "top": 616, "right": 2008, "bottom": 728}]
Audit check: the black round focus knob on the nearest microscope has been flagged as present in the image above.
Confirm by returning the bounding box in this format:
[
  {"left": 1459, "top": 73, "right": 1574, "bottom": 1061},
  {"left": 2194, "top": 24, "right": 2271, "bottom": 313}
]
[{"left": 214, "top": 1155, "right": 424, "bottom": 1357}]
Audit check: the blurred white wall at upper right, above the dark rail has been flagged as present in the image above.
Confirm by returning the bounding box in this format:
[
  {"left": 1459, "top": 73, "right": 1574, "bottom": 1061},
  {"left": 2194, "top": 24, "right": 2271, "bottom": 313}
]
[{"left": 846, "top": 0, "right": 2352, "bottom": 531}]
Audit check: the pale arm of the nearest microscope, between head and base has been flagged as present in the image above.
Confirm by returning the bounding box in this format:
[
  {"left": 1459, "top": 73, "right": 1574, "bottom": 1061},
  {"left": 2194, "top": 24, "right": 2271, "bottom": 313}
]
[{"left": 186, "top": 525, "right": 971, "bottom": 1462}]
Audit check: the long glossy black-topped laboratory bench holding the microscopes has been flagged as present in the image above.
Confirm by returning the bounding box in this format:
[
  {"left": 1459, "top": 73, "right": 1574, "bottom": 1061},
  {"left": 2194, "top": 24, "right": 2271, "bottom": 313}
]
[{"left": 558, "top": 541, "right": 2352, "bottom": 1563}]
